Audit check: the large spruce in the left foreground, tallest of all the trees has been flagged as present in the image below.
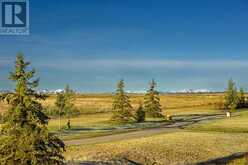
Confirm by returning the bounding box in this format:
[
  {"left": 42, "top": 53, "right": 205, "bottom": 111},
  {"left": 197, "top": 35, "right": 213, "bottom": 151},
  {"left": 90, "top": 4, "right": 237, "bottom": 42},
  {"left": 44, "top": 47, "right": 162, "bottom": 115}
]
[{"left": 0, "top": 55, "right": 65, "bottom": 165}]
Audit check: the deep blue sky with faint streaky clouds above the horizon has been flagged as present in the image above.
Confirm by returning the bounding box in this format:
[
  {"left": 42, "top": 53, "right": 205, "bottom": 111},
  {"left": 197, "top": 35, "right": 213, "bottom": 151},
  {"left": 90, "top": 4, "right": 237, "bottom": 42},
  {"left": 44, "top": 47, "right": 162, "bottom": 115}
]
[{"left": 0, "top": 0, "right": 248, "bottom": 92}]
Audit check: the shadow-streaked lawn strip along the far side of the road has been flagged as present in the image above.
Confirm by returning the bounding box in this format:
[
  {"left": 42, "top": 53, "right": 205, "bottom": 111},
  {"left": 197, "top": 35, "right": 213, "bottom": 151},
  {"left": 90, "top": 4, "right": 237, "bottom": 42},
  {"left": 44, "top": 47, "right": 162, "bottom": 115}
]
[{"left": 48, "top": 113, "right": 168, "bottom": 140}]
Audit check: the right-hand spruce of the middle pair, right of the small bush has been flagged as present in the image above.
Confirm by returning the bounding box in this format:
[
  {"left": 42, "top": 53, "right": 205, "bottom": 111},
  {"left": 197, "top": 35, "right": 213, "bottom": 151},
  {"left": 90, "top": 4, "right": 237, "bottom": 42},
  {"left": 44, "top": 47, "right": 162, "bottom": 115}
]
[{"left": 144, "top": 80, "right": 164, "bottom": 117}]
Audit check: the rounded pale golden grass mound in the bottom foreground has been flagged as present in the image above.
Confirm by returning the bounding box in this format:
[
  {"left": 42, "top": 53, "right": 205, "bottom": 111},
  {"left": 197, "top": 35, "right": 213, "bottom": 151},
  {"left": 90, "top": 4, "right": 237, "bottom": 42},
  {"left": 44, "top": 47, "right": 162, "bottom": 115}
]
[{"left": 65, "top": 132, "right": 248, "bottom": 164}]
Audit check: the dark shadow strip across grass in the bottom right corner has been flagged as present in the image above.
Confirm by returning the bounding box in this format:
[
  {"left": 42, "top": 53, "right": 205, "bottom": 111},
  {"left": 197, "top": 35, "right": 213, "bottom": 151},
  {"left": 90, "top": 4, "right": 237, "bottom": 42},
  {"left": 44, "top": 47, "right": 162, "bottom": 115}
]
[{"left": 195, "top": 152, "right": 248, "bottom": 165}]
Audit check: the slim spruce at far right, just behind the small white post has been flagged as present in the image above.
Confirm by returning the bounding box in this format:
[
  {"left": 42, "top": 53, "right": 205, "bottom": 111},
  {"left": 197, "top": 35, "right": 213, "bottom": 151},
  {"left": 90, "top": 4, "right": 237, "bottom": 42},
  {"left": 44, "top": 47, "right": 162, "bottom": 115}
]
[{"left": 225, "top": 79, "right": 238, "bottom": 110}]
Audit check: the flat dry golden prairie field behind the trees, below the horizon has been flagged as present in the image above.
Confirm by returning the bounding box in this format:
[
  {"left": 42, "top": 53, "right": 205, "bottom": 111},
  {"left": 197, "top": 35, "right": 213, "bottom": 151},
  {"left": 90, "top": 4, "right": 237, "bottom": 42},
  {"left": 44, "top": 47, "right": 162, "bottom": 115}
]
[{"left": 0, "top": 93, "right": 223, "bottom": 113}]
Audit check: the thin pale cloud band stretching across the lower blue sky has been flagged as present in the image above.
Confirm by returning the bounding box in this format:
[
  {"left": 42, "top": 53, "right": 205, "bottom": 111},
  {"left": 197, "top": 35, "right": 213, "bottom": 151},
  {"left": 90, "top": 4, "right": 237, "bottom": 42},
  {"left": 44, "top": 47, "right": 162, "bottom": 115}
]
[{"left": 35, "top": 59, "right": 248, "bottom": 70}]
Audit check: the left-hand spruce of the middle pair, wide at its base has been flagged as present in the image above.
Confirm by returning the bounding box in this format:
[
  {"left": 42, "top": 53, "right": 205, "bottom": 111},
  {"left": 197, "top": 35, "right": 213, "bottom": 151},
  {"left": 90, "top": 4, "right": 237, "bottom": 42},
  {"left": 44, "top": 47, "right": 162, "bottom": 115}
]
[{"left": 111, "top": 80, "right": 135, "bottom": 122}]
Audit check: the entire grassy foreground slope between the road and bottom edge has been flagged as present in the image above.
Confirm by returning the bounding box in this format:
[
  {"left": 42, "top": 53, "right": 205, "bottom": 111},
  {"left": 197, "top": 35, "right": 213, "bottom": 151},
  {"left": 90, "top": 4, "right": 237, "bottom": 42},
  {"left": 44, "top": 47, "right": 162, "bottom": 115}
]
[{"left": 65, "top": 108, "right": 248, "bottom": 165}]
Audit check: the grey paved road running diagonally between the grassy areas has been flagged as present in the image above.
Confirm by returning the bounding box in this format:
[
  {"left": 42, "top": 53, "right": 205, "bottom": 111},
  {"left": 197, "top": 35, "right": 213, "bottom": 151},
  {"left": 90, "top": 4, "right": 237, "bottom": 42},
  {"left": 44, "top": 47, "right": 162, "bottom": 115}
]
[{"left": 65, "top": 114, "right": 225, "bottom": 145}]
